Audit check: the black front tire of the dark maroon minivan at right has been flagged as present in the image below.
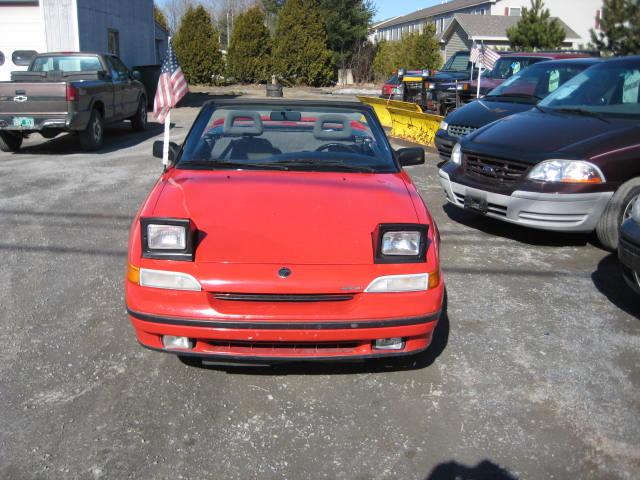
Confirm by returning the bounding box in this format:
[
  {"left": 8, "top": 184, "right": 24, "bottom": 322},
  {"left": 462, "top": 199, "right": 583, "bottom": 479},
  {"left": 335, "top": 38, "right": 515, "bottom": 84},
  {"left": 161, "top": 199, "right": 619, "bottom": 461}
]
[{"left": 596, "top": 178, "right": 640, "bottom": 252}]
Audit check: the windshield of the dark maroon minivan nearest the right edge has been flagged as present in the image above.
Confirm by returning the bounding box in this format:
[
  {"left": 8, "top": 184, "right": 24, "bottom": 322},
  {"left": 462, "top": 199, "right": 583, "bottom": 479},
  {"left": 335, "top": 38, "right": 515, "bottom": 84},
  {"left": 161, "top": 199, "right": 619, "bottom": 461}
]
[{"left": 540, "top": 60, "right": 640, "bottom": 119}]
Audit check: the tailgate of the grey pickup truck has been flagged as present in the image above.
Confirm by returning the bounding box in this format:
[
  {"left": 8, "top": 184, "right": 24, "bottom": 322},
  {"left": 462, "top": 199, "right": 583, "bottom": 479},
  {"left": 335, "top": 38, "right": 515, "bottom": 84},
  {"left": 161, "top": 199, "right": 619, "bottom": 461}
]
[{"left": 0, "top": 82, "right": 68, "bottom": 115}]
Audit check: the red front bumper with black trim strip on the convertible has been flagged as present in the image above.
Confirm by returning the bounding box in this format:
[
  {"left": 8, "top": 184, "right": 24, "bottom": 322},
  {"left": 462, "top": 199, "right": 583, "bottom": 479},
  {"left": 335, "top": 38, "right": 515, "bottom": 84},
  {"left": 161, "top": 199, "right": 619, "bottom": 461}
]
[{"left": 126, "top": 276, "right": 444, "bottom": 361}]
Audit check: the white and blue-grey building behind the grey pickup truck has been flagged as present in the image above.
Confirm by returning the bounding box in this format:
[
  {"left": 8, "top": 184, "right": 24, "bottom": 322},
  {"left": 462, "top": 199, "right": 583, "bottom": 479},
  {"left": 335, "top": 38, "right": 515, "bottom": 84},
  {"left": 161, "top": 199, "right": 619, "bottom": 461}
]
[{"left": 0, "top": 0, "right": 168, "bottom": 80}]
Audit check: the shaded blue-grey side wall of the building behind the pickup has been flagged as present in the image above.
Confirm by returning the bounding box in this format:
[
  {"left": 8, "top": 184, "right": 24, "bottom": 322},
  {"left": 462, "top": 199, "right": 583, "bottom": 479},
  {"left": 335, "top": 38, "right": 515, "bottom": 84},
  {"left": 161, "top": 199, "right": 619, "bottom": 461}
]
[{"left": 77, "top": 0, "right": 156, "bottom": 67}]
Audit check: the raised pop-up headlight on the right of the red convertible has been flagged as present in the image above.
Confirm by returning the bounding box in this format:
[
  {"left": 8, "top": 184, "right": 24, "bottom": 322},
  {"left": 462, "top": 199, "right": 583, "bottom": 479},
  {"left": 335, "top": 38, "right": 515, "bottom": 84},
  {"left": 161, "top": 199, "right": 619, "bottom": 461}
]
[{"left": 374, "top": 223, "right": 428, "bottom": 263}]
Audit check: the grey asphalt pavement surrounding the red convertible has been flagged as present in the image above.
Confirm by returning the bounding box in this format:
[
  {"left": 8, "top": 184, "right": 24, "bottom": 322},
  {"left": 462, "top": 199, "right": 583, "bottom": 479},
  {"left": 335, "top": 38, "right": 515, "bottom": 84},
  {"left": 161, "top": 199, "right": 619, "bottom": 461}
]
[{"left": 0, "top": 93, "right": 640, "bottom": 480}]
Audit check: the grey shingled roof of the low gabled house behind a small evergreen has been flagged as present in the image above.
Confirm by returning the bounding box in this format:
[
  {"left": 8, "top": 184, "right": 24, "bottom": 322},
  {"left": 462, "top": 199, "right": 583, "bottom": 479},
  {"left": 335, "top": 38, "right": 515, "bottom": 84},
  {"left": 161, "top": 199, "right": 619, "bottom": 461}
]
[{"left": 440, "top": 13, "right": 580, "bottom": 40}]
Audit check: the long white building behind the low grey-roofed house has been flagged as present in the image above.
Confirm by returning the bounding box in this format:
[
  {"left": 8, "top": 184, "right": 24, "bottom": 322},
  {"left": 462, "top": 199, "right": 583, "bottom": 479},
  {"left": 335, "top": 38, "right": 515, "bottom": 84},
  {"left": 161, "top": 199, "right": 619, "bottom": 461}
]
[{"left": 369, "top": 0, "right": 603, "bottom": 52}]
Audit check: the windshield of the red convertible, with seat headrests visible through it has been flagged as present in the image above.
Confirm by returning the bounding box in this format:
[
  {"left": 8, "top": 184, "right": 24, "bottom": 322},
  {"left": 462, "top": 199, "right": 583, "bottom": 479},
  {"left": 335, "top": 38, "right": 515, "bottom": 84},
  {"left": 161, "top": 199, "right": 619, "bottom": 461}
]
[{"left": 177, "top": 104, "right": 398, "bottom": 172}]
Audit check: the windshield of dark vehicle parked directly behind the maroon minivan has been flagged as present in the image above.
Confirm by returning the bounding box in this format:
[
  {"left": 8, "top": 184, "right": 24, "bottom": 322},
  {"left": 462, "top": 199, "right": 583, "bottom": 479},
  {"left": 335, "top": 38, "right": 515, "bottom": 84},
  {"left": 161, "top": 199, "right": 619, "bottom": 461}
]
[{"left": 486, "top": 62, "right": 589, "bottom": 100}]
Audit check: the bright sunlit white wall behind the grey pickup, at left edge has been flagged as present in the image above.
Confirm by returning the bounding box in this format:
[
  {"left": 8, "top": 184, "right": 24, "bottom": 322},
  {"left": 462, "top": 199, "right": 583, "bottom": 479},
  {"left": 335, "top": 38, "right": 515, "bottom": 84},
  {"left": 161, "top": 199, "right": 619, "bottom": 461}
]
[{"left": 0, "top": 5, "right": 47, "bottom": 81}]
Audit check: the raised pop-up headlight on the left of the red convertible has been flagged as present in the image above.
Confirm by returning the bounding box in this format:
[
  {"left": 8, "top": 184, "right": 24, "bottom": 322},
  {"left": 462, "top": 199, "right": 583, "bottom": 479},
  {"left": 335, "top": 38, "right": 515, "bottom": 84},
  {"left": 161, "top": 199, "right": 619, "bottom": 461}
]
[{"left": 140, "top": 218, "right": 195, "bottom": 261}]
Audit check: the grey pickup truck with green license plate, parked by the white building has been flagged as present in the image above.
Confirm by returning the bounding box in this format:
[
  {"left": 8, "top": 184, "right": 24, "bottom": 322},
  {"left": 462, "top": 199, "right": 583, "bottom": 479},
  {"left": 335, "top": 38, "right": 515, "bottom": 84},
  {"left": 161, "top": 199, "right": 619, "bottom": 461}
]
[{"left": 0, "top": 52, "right": 147, "bottom": 152}]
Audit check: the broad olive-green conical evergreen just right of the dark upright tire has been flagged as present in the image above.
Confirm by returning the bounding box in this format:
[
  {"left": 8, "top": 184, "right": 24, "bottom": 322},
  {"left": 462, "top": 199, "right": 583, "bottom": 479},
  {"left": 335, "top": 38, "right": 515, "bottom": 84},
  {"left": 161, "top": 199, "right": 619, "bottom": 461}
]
[{"left": 273, "top": 0, "right": 334, "bottom": 86}]
